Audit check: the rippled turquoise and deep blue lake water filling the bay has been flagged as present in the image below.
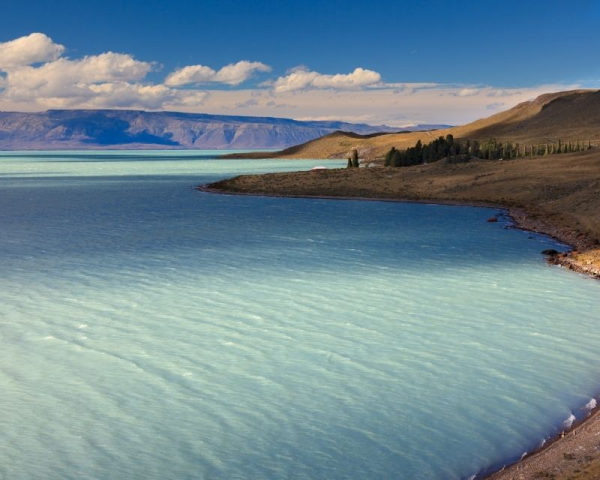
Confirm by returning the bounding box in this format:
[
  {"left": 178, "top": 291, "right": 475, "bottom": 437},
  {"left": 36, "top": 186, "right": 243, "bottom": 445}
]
[{"left": 0, "top": 151, "right": 600, "bottom": 480}]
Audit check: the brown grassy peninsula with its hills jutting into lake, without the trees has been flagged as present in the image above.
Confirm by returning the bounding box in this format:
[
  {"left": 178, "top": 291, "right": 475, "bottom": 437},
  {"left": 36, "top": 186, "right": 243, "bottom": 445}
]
[{"left": 211, "top": 90, "right": 600, "bottom": 276}]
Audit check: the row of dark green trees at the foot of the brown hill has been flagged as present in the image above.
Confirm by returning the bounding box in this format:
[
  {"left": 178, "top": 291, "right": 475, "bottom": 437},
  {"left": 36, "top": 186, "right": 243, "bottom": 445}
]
[{"left": 385, "top": 135, "right": 592, "bottom": 167}]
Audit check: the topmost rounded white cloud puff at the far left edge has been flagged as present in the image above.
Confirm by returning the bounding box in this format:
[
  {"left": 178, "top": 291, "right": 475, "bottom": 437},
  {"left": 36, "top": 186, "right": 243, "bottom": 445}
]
[{"left": 0, "top": 33, "right": 65, "bottom": 71}]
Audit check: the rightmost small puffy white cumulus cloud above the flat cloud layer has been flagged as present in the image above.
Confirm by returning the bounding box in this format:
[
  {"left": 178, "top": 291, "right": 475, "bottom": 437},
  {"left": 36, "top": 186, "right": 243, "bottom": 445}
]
[{"left": 273, "top": 68, "right": 381, "bottom": 93}]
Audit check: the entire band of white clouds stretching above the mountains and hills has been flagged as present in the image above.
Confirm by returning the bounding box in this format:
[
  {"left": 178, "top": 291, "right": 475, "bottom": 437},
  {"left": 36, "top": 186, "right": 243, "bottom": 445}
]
[{"left": 0, "top": 33, "right": 580, "bottom": 126}]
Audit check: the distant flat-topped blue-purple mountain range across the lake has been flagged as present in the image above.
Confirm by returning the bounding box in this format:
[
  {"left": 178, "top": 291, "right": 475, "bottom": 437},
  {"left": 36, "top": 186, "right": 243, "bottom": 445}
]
[{"left": 0, "top": 110, "right": 447, "bottom": 150}]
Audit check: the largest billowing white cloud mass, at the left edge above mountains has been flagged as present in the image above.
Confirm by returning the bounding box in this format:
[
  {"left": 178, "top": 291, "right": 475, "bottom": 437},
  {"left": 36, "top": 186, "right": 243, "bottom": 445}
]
[{"left": 0, "top": 33, "right": 208, "bottom": 110}]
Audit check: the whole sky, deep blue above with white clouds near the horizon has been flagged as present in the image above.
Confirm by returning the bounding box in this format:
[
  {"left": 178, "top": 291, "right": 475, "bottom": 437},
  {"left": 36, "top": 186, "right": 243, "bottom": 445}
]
[{"left": 0, "top": 0, "right": 600, "bottom": 124}]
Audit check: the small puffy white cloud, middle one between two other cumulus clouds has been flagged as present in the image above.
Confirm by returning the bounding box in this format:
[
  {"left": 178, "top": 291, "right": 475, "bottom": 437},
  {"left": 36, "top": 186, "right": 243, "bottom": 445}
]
[{"left": 165, "top": 60, "right": 271, "bottom": 87}]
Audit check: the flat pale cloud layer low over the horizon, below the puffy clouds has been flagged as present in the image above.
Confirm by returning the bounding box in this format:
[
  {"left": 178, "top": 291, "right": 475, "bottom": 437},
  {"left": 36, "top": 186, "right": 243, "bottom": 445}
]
[{"left": 190, "top": 83, "right": 576, "bottom": 127}]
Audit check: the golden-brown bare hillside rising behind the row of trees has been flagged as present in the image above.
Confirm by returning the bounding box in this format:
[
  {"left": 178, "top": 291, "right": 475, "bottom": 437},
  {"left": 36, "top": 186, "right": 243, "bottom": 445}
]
[{"left": 224, "top": 90, "right": 600, "bottom": 160}]
